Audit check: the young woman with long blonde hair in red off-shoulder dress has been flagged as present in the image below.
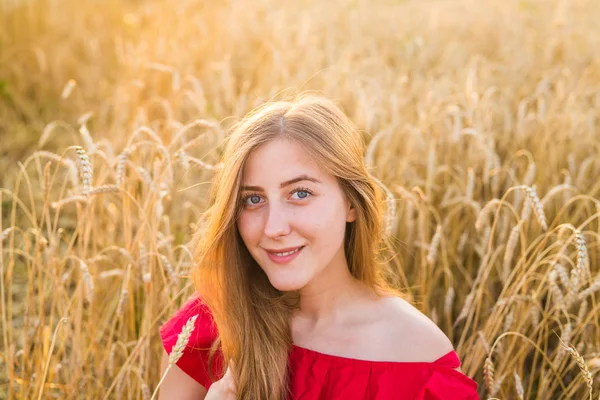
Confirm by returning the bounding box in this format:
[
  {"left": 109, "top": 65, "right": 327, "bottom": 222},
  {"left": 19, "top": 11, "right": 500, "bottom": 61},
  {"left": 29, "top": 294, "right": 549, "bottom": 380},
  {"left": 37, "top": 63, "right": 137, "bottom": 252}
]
[{"left": 160, "top": 96, "right": 478, "bottom": 400}]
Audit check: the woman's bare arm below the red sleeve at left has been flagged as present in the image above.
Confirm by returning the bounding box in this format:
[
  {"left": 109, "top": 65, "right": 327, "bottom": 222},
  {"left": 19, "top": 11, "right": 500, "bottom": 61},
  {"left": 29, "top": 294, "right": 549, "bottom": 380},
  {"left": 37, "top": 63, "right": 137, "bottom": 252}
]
[{"left": 158, "top": 351, "right": 207, "bottom": 400}]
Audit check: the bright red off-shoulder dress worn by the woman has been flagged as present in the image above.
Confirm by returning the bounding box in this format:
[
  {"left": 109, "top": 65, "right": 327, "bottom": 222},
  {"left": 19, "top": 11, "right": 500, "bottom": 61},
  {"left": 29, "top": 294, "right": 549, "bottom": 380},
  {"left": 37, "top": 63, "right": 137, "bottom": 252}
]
[{"left": 160, "top": 297, "right": 479, "bottom": 400}]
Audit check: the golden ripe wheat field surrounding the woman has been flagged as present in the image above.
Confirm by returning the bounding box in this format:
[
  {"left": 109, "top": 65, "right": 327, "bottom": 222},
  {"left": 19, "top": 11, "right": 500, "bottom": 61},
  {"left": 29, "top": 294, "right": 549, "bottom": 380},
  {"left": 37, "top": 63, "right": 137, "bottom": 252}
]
[{"left": 0, "top": 0, "right": 600, "bottom": 399}]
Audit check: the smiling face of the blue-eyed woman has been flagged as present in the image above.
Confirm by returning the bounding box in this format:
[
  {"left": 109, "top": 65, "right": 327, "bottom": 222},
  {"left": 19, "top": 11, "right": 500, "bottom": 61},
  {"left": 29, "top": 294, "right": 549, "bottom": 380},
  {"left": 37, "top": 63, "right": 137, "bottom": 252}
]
[{"left": 237, "top": 139, "right": 356, "bottom": 291}]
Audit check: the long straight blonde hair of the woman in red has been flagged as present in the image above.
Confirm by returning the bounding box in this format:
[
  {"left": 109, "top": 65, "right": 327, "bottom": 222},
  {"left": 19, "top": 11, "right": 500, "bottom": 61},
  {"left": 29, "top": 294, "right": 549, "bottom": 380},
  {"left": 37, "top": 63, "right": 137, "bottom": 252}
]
[{"left": 193, "top": 95, "right": 397, "bottom": 400}]
